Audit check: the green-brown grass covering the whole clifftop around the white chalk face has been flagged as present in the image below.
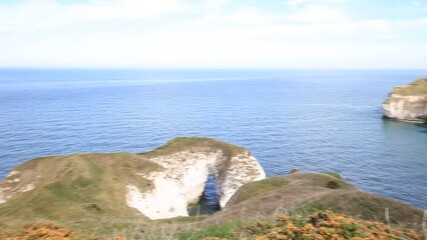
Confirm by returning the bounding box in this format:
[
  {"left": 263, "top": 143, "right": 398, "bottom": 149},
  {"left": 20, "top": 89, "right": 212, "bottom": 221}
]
[{"left": 0, "top": 138, "right": 423, "bottom": 240}]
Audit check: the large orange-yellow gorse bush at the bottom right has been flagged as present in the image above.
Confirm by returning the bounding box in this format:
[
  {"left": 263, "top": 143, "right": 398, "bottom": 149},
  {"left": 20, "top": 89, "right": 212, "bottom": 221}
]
[{"left": 239, "top": 211, "right": 422, "bottom": 240}]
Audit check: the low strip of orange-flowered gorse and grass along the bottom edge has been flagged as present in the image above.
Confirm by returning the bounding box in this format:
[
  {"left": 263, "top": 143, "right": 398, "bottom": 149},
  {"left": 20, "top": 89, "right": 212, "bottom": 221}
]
[{"left": 0, "top": 211, "right": 423, "bottom": 240}]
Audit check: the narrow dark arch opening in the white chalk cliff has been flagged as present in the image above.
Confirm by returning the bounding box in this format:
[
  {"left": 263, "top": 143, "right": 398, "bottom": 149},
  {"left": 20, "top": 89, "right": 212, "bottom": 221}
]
[{"left": 188, "top": 175, "right": 220, "bottom": 216}]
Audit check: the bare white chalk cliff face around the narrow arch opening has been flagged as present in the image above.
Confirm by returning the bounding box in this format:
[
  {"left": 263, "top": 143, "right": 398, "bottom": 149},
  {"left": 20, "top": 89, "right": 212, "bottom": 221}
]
[{"left": 126, "top": 143, "right": 265, "bottom": 219}]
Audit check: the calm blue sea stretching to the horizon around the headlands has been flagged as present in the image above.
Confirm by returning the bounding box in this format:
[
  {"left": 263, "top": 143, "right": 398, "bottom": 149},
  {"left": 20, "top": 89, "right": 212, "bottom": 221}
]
[{"left": 0, "top": 69, "right": 427, "bottom": 208}]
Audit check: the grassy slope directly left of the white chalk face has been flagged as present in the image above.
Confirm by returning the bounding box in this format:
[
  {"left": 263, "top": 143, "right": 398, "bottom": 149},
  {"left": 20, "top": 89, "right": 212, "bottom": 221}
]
[{"left": 0, "top": 153, "right": 158, "bottom": 226}]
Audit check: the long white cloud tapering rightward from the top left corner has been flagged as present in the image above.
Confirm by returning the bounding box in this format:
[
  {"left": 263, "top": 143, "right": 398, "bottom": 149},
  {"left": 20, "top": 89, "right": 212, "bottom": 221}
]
[{"left": 0, "top": 0, "right": 183, "bottom": 31}]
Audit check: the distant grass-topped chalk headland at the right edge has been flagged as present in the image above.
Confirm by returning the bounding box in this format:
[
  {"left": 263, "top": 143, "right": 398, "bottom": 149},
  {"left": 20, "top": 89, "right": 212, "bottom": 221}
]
[{"left": 382, "top": 78, "right": 427, "bottom": 123}]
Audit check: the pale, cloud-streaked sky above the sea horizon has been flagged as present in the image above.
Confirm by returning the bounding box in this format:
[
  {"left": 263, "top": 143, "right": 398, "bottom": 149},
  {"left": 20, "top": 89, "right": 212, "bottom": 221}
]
[{"left": 0, "top": 0, "right": 427, "bottom": 69}]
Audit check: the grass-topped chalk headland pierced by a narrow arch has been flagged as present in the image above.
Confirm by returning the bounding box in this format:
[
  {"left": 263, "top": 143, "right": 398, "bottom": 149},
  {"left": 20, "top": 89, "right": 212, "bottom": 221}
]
[{"left": 0, "top": 138, "right": 265, "bottom": 219}]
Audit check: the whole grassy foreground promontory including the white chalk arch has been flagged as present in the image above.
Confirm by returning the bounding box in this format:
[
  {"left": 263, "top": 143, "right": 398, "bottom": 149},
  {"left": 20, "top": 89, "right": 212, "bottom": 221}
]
[{"left": 0, "top": 137, "right": 423, "bottom": 240}]
